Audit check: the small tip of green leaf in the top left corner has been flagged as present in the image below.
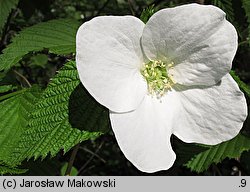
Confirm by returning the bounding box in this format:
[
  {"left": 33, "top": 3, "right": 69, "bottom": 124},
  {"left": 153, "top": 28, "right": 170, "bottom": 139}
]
[{"left": 0, "top": 0, "right": 19, "bottom": 33}]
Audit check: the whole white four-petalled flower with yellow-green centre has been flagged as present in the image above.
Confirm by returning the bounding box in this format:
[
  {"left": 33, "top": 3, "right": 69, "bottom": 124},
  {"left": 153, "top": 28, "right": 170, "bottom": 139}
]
[{"left": 76, "top": 4, "right": 247, "bottom": 172}]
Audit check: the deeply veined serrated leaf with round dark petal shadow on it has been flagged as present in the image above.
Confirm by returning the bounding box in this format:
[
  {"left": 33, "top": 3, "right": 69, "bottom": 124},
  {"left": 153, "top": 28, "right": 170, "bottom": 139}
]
[{"left": 9, "top": 62, "right": 110, "bottom": 165}]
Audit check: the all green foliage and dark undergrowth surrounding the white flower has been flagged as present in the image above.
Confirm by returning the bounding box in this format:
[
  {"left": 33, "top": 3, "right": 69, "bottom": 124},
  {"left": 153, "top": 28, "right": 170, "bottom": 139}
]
[{"left": 0, "top": 0, "right": 250, "bottom": 175}]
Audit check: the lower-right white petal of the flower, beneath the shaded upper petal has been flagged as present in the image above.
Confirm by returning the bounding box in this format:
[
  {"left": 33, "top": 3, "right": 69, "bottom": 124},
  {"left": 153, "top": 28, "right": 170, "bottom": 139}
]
[{"left": 173, "top": 74, "right": 247, "bottom": 145}]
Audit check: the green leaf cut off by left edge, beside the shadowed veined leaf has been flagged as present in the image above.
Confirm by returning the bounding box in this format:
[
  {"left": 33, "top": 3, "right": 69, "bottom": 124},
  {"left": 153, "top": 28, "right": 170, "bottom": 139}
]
[{"left": 0, "top": 87, "right": 40, "bottom": 162}]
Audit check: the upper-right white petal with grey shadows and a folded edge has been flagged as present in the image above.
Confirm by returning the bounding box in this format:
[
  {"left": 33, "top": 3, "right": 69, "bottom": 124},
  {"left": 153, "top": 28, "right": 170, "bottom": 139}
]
[{"left": 142, "top": 4, "right": 238, "bottom": 85}]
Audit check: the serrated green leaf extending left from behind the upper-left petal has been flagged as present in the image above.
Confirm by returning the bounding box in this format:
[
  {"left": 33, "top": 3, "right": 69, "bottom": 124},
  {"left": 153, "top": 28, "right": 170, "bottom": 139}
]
[{"left": 0, "top": 19, "right": 80, "bottom": 70}]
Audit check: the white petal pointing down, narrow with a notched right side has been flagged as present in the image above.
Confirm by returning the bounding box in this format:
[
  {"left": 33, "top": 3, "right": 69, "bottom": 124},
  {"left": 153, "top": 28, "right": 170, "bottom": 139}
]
[{"left": 110, "top": 92, "right": 179, "bottom": 173}]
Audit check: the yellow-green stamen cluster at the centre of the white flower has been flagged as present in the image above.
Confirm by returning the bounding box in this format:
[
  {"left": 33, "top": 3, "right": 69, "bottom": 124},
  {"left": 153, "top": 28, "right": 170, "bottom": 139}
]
[{"left": 141, "top": 60, "right": 175, "bottom": 98}]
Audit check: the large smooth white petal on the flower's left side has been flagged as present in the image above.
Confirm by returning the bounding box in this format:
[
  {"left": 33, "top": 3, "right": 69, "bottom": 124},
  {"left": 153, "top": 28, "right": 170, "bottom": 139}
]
[{"left": 76, "top": 16, "right": 147, "bottom": 112}]
